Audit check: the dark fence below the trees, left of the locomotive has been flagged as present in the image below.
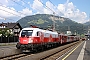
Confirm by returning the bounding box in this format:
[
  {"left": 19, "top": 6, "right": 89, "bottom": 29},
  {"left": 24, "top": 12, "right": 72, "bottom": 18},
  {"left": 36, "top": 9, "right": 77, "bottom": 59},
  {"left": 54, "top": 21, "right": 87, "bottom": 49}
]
[{"left": 0, "top": 36, "right": 18, "bottom": 43}]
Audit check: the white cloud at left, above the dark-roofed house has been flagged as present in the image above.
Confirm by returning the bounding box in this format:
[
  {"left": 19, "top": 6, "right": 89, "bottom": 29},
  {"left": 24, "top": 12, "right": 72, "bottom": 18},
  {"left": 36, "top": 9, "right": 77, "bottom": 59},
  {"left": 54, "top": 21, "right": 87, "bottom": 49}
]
[{"left": 0, "top": 5, "right": 32, "bottom": 22}]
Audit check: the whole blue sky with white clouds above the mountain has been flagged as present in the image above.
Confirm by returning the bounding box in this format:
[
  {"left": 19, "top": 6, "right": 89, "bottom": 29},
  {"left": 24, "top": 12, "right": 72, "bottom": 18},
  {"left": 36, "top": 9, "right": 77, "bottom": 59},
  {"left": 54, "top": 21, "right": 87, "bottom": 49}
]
[{"left": 0, "top": 0, "right": 90, "bottom": 23}]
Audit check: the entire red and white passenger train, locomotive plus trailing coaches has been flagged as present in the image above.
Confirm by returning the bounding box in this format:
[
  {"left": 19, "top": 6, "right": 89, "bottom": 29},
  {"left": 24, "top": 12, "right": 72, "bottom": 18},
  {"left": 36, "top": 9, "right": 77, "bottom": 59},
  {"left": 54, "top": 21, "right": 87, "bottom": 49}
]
[{"left": 16, "top": 27, "right": 79, "bottom": 51}]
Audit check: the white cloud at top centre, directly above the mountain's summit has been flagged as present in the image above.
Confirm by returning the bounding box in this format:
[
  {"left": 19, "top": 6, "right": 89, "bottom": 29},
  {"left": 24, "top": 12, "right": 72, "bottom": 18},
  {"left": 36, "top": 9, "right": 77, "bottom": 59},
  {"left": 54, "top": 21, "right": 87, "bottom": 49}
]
[{"left": 32, "top": 0, "right": 55, "bottom": 14}]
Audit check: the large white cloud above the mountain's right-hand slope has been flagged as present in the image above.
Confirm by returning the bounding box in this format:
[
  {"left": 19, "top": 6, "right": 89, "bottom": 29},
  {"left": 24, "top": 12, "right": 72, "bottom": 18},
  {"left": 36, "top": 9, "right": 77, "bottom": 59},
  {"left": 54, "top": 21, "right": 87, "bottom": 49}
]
[{"left": 57, "top": 2, "right": 88, "bottom": 23}]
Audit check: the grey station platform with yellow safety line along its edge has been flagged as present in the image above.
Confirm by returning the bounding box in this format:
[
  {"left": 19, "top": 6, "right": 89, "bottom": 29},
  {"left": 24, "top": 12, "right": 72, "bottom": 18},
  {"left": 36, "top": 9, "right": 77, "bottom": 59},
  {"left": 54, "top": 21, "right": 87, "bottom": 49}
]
[{"left": 58, "top": 40, "right": 90, "bottom": 60}]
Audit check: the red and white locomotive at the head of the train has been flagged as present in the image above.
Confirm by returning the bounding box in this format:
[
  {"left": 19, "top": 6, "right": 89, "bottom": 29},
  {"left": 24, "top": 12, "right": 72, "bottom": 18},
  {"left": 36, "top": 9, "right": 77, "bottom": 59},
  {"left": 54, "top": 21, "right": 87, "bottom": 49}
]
[{"left": 16, "top": 28, "right": 60, "bottom": 50}]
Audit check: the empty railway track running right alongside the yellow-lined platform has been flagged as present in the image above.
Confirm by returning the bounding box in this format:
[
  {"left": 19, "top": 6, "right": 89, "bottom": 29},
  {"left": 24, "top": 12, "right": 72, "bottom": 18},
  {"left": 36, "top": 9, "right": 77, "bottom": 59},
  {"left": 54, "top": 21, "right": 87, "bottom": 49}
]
[{"left": 40, "top": 41, "right": 81, "bottom": 60}]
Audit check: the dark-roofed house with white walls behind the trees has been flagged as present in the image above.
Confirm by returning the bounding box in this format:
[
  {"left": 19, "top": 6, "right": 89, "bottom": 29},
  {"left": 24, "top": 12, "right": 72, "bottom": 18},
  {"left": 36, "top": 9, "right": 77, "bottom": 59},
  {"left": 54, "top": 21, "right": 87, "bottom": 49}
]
[{"left": 0, "top": 22, "right": 22, "bottom": 36}]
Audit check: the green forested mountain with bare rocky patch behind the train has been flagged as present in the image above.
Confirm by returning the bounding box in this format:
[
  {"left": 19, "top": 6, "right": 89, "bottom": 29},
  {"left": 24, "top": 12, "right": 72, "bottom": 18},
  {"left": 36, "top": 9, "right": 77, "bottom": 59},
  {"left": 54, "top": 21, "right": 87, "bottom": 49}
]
[{"left": 17, "top": 14, "right": 85, "bottom": 34}]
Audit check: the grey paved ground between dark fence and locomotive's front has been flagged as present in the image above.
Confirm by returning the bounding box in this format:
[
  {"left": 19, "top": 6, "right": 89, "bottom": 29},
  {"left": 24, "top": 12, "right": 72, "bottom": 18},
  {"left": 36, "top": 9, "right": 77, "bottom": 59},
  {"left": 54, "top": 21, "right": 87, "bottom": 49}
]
[{"left": 0, "top": 43, "right": 21, "bottom": 58}]
